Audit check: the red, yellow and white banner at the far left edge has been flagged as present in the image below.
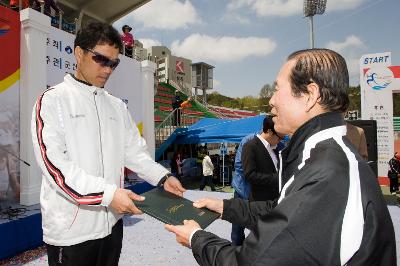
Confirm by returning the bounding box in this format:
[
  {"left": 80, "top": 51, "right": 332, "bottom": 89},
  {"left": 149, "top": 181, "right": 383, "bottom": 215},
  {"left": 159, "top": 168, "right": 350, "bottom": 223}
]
[{"left": 0, "top": 6, "right": 20, "bottom": 202}]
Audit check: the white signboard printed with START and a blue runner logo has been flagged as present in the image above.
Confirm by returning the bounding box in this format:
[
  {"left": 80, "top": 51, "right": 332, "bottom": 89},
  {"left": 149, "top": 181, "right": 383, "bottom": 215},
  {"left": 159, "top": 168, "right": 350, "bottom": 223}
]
[{"left": 360, "top": 52, "right": 394, "bottom": 176}]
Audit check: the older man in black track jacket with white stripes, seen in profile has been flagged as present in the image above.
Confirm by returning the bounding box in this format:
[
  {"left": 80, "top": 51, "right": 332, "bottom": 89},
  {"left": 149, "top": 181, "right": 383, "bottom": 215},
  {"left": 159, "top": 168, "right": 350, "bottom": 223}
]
[{"left": 166, "top": 49, "right": 396, "bottom": 266}]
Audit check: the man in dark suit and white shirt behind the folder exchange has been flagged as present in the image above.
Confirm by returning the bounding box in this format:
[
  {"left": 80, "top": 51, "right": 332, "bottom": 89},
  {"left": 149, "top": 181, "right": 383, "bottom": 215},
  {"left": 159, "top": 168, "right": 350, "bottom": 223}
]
[{"left": 242, "top": 116, "right": 281, "bottom": 201}]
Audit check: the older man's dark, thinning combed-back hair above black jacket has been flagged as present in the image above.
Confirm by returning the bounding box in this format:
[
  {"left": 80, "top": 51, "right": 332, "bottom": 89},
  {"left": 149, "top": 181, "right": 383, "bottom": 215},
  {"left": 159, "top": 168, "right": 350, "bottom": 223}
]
[{"left": 288, "top": 49, "right": 349, "bottom": 112}]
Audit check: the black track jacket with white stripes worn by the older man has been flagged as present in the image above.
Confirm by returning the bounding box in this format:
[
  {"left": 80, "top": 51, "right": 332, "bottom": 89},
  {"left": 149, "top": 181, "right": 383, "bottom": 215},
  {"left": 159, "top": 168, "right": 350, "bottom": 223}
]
[{"left": 191, "top": 113, "right": 396, "bottom": 266}]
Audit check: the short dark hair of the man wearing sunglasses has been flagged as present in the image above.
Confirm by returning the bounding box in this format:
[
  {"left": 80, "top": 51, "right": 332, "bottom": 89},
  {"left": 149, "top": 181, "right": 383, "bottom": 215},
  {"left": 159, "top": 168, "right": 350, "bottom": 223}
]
[{"left": 74, "top": 22, "right": 122, "bottom": 50}]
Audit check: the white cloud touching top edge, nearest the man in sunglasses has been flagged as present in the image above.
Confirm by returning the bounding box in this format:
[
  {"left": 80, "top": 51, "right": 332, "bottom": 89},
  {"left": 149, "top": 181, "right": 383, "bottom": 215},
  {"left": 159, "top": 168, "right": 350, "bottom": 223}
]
[{"left": 129, "top": 0, "right": 201, "bottom": 30}]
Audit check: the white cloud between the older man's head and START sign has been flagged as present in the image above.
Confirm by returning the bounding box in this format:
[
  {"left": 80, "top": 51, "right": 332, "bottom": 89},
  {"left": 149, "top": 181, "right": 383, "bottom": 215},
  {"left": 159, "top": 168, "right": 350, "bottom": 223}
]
[{"left": 326, "top": 35, "right": 366, "bottom": 84}]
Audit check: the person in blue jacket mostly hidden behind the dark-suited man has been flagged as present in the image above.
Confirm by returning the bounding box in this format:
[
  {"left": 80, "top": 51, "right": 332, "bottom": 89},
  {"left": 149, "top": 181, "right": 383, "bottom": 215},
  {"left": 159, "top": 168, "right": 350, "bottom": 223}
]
[{"left": 231, "top": 133, "right": 257, "bottom": 246}]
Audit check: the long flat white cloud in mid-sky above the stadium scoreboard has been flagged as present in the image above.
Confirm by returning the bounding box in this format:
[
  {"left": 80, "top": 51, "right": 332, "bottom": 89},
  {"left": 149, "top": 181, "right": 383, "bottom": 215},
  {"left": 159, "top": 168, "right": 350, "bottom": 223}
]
[{"left": 171, "top": 34, "right": 276, "bottom": 62}]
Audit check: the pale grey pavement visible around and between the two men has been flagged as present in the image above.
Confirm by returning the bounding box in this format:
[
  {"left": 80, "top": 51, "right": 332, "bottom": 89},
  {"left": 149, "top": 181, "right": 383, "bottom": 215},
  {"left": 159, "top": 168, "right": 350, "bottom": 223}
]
[{"left": 27, "top": 190, "right": 400, "bottom": 266}]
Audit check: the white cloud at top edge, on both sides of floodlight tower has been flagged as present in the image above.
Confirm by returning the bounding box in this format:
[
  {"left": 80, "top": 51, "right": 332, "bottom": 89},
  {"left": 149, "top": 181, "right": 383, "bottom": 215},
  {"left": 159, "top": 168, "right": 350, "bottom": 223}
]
[{"left": 227, "top": 0, "right": 365, "bottom": 17}]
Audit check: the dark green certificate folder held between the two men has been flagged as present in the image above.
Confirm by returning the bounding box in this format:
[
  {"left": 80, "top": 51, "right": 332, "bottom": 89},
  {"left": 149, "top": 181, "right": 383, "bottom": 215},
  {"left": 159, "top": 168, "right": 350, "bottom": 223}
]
[{"left": 134, "top": 187, "right": 220, "bottom": 229}]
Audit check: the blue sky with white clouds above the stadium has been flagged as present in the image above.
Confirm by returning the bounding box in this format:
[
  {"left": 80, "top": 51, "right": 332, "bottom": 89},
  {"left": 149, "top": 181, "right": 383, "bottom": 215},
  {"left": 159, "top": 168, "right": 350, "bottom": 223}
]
[{"left": 114, "top": 0, "right": 400, "bottom": 97}]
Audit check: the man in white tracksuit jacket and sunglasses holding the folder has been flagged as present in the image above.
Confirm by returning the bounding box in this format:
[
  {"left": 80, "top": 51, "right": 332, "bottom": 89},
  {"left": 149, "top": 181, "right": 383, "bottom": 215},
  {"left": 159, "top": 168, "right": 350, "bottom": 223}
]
[{"left": 32, "top": 23, "right": 184, "bottom": 265}]
